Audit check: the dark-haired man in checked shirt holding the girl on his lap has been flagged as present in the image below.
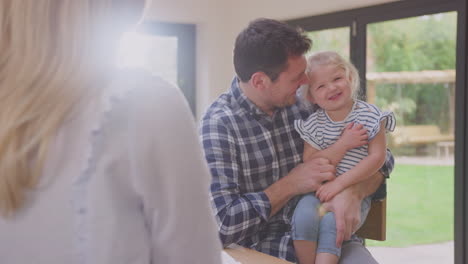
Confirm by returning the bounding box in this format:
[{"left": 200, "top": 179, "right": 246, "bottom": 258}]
[{"left": 201, "top": 19, "right": 393, "bottom": 263}]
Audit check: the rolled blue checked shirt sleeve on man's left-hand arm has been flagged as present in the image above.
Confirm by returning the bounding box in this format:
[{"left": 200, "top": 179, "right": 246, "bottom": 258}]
[{"left": 200, "top": 117, "right": 271, "bottom": 246}]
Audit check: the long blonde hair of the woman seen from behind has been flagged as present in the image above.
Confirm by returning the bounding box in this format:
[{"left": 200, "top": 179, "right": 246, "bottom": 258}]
[{"left": 0, "top": 0, "right": 148, "bottom": 217}]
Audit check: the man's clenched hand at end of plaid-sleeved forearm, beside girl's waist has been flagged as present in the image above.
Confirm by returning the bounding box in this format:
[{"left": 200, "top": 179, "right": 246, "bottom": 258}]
[{"left": 285, "top": 158, "right": 335, "bottom": 195}]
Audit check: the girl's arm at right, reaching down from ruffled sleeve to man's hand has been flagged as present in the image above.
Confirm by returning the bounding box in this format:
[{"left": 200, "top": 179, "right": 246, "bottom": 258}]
[{"left": 316, "top": 121, "right": 387, "bottom": 201}]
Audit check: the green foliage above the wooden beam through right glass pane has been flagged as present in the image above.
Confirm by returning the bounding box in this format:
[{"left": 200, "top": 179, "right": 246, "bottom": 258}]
[{"left": 367, "top": 12, "right": 456, "bottom": 72}]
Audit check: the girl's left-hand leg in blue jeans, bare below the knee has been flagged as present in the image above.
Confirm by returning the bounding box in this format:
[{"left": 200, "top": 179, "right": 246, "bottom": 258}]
[{"left": 292, "top": 194, "right": 320, "bottom": 264}]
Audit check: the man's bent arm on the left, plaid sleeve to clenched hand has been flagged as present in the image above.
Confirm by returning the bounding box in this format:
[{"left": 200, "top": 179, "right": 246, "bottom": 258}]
[{"left": 200, "top": 114, "right": 335, "bottom": 246}]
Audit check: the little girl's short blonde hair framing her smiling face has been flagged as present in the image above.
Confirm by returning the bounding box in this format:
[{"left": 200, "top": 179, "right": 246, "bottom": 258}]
[{"left": 306, "top": 51, "right": 359, "bottom": 100}]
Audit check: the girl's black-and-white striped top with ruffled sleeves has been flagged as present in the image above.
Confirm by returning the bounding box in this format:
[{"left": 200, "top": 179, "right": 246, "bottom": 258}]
[{"left": 294, "top": 100, "right": 395, "bottom": 175}]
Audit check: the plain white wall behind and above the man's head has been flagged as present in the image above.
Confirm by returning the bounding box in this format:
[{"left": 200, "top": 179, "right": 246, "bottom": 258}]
[{"left": 148, "top": 0, "right": 397, "bottom": 116}]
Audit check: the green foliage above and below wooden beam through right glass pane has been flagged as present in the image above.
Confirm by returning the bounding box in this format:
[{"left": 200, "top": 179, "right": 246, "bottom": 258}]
[{"left": 367, "top": 12, "right": 456, "bottom": 131}]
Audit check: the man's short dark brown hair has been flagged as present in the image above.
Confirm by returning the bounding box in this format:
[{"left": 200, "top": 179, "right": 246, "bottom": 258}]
[{"left": 234, "top": 18, "right": 312, "bottom": 82}]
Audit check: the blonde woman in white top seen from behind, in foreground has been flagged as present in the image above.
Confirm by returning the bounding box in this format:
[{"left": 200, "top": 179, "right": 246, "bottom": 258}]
[{"left": 0, "top": 0, "right": 221, "bottom": 264}]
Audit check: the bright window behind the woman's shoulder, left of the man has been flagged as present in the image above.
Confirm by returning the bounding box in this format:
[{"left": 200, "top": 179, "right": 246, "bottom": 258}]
[{"left": 118, "top": 21, "right": 195, "bottom": 114}]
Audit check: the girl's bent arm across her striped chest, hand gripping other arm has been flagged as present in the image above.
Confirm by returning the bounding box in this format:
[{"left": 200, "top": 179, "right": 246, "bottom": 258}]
[{"left": 302, "top": 123, "right": 367, "bottom": 166}]
